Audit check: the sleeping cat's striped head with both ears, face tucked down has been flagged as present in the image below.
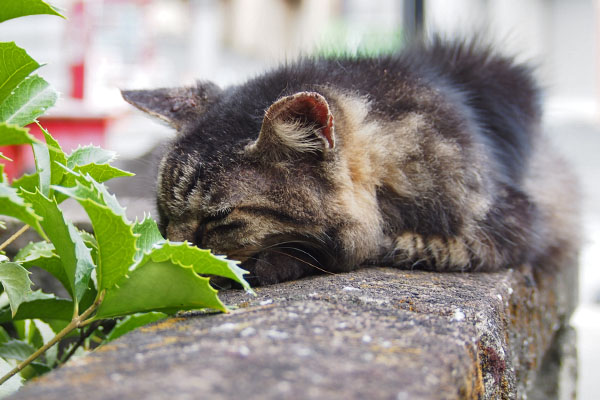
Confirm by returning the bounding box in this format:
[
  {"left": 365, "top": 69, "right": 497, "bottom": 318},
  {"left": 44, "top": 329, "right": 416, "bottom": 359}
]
[{"left": 123, "top": 83, "right": 379, "bottom": 284}]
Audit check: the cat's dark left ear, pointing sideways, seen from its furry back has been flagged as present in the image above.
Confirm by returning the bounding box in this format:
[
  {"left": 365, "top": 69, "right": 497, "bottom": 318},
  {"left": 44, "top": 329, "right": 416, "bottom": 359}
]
[{"left": 121, "top": 82, "right": 221, "bottom": 130}]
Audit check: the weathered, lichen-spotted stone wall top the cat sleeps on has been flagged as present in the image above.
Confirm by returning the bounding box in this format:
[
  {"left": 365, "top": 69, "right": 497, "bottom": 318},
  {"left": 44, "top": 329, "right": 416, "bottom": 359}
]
[{"left": 13, "top": 267, "right": 576, "bottom": 400}]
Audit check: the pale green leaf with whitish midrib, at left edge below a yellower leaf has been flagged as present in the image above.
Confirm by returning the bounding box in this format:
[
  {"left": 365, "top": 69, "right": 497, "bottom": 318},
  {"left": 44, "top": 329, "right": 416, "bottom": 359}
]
[{"left": 0, "top": 75, "right": 58, "bottom": 126}]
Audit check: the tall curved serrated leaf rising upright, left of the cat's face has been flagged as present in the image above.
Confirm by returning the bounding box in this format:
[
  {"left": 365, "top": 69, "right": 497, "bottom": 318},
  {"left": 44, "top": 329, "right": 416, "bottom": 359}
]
[{"left": 53, "top": 177, "right": 136, "bottom": 291}]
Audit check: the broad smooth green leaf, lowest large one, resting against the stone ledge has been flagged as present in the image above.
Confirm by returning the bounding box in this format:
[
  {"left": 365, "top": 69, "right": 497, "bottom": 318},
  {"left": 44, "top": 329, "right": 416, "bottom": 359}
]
[{"left": 95, "top": 261, "right": 227, "bottom": 318}]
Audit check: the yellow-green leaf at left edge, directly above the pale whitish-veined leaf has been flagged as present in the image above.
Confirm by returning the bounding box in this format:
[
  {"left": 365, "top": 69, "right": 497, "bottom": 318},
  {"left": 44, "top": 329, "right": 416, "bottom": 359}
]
[{"left": 0, "top": 42, "right": 40, "bottom": 104}]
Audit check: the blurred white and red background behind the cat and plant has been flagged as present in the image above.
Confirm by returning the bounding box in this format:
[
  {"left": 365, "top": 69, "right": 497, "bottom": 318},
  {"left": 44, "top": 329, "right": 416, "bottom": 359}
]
[{"left": 0, "top": 0, "right": 600, "bottom": 399}]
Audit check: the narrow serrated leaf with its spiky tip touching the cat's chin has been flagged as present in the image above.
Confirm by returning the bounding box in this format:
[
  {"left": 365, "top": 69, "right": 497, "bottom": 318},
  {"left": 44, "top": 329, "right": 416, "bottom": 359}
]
[{"left": 142, "top": 240, "right": 252, "bottom": 292}]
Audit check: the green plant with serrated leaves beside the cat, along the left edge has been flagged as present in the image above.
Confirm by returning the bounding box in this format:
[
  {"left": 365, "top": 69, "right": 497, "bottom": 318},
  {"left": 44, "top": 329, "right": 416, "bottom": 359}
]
[{"left": 0, "top": 0, "right": 251, "bottom": 396}]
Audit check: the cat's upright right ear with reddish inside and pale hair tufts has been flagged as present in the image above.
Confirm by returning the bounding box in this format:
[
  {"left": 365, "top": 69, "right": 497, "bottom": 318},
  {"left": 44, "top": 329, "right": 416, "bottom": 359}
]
[{"left": 253, "top": 92, "right": 335, "bottom": 153}]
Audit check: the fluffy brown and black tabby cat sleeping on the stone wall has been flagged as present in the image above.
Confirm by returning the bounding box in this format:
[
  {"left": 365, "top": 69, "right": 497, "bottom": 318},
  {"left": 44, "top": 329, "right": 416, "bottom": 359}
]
[{"left": 123, "top": 39, "right": 577, "bottom": 285}]
